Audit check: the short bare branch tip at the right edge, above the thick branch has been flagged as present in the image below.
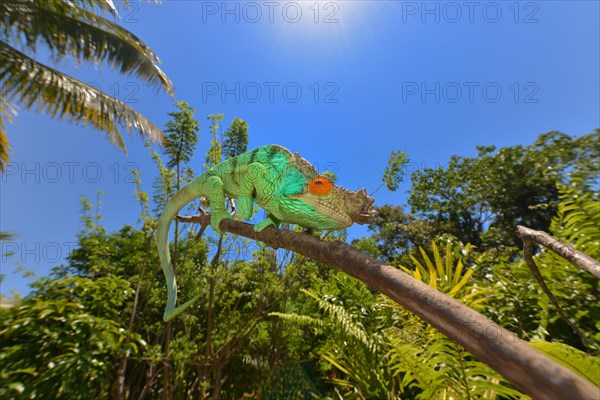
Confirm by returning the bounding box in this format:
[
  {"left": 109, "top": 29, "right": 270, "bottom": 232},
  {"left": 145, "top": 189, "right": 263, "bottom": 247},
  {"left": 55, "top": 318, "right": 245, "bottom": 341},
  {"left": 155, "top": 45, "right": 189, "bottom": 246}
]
[{"left": 517, "top": 225, "right": 600, "bottom": 279}]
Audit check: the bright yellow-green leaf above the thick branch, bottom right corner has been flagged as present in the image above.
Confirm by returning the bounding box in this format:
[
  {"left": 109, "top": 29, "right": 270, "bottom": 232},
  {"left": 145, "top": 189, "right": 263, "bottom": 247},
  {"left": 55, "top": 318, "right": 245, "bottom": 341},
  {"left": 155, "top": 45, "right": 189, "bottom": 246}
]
[{"left": 529, "top": 341, "right": 600, "bottom": 387}]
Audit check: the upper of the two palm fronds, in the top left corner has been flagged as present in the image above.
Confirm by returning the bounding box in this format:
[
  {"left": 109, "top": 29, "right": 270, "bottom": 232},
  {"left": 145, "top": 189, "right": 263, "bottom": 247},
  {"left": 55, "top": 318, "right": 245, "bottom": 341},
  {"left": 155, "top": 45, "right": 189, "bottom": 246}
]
[{"left": 0, "top": 0, "right": 173, "bottom": 96}]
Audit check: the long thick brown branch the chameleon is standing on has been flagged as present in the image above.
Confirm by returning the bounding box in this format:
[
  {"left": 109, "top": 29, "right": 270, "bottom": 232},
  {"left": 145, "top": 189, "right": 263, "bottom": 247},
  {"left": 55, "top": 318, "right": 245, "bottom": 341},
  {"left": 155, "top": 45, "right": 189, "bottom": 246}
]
[{"left": 177, "top": 215, "right": 600, "bottom": 399}]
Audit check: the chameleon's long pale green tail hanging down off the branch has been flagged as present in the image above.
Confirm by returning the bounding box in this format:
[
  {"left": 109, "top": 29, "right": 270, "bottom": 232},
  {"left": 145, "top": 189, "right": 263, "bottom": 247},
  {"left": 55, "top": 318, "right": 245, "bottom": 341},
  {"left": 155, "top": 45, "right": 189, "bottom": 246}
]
[{"left": 156, "top": 179, "right": 202, "bottom": 321}]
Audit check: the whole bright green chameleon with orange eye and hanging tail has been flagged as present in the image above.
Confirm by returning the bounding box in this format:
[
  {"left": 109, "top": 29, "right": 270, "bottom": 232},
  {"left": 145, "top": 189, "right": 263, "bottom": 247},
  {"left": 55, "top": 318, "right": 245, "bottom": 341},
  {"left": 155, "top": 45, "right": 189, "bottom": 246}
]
[{"left": 156, "top": 145, "right": 377, "bottom": 321}]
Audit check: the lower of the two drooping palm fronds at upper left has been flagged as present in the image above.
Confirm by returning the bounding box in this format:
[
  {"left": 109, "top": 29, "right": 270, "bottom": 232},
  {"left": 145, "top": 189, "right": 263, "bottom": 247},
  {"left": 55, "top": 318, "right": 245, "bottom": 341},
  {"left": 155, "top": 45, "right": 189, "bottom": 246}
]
[{"left": 0, "top": 41, "right": 163, "bottom": 150}]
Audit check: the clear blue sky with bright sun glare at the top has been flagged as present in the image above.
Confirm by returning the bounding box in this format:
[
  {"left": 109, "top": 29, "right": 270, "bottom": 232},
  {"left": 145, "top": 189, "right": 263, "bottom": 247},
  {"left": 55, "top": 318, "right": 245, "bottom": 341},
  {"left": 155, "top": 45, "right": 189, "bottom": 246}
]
[{"left": 0, "top": 0, "right": 600, "bottom": 295}]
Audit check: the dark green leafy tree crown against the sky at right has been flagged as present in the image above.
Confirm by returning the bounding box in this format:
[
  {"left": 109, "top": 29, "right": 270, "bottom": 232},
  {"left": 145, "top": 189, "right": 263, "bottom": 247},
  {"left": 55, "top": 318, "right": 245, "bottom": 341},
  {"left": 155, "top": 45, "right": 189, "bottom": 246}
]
[{"left": 408, "top": 131, "right": 600, "bottom": 251}]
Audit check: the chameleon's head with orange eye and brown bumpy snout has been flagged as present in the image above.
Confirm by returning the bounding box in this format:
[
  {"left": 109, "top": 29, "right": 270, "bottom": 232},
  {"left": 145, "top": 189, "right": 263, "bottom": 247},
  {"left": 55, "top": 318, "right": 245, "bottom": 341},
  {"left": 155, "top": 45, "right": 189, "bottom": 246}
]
[{"left": 290, "top": 176, "right": 377, "bottom": 229}]
